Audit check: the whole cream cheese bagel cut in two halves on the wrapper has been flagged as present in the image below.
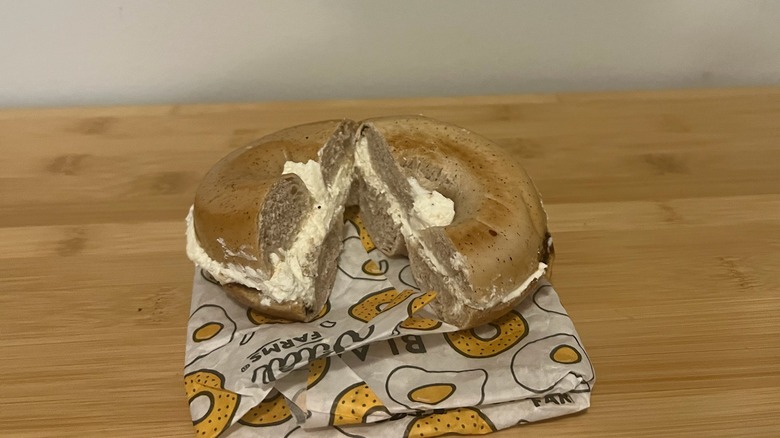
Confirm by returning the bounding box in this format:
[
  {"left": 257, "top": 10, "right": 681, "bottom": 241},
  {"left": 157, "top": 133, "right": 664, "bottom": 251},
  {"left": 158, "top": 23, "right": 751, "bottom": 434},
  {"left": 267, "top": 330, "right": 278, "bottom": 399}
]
[{"left": 187, "top": 116, "right": 553, "bottom": 328}]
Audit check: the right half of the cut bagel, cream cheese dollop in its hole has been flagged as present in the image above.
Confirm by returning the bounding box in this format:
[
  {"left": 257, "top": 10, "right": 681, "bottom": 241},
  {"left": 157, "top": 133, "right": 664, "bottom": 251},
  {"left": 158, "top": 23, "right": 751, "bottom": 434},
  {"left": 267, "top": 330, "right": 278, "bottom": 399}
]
[{"left": 356, "top": 116, "right": 552, "bottom": 328}]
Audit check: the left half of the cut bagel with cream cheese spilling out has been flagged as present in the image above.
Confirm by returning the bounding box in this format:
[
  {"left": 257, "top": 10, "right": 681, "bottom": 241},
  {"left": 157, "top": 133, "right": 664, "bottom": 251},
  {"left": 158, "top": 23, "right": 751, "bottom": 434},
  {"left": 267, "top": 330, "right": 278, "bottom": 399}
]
[{"left": 187, "top": 120, "right": 356, "bottom": 321}]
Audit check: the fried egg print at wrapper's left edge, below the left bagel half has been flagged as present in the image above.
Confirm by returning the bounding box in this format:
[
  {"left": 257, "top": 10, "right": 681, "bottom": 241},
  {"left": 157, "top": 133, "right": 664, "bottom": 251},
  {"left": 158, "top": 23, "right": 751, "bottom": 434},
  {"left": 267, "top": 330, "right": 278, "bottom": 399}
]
[{"left": 185, "top": 304, "right": 236, "bottom": 367}]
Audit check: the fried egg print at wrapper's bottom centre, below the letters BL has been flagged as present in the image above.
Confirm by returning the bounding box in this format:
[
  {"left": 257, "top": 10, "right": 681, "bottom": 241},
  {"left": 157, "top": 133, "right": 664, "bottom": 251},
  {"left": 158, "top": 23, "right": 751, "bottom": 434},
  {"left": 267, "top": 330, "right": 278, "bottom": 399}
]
[{"left": 385, "top": 365, "right": 488, "bottom": 410}]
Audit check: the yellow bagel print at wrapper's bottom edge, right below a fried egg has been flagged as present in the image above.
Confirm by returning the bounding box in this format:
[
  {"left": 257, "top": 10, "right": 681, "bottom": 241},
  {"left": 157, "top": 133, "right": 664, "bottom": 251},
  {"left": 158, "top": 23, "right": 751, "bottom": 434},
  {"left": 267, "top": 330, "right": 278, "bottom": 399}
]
[{"left": 404, "top": 408, "right": 496, "bottom": 438}]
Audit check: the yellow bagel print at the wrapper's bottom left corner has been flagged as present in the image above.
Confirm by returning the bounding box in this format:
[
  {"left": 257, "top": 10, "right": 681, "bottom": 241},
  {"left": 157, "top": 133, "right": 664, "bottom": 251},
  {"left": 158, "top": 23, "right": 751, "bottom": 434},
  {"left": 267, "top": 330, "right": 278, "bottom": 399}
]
[{"left": 184, "top": 370, "right": 241, "bottom": 437}]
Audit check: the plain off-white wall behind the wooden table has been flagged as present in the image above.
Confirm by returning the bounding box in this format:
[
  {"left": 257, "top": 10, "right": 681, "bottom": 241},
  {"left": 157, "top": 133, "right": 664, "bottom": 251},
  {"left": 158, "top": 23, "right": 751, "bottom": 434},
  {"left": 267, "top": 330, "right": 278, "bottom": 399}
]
[{"left": 0, "top": 0, "right": 780, "bottom": 107}]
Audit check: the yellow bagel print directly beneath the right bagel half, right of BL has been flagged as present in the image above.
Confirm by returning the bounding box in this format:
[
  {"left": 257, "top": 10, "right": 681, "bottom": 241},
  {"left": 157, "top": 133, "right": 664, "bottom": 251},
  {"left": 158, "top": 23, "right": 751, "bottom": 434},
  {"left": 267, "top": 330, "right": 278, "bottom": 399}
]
[{"left": 444, "top": 310, "right": 528, "bottom": 359}]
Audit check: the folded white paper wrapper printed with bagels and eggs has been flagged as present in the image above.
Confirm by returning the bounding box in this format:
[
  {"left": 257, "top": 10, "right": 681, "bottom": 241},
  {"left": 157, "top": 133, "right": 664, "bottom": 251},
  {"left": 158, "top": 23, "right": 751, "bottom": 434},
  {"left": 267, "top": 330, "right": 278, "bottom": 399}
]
[{"left": 184, "top": 211, "right": 595, "bottom": 437}]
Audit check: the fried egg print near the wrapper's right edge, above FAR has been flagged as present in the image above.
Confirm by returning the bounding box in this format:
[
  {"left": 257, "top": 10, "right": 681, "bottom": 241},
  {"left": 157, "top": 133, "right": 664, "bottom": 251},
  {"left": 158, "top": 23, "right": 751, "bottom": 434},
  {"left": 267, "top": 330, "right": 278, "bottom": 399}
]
[{"left": 512, "top": 333, "right": 593, "bottom": 393}]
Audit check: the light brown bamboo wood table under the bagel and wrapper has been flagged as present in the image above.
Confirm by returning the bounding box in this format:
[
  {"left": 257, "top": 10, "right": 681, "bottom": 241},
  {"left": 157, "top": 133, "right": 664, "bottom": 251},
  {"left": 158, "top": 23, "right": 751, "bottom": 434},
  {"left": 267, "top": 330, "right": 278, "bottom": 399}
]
[{"left": 0, "top": 88, "right": 780, "bottom": 437}]
